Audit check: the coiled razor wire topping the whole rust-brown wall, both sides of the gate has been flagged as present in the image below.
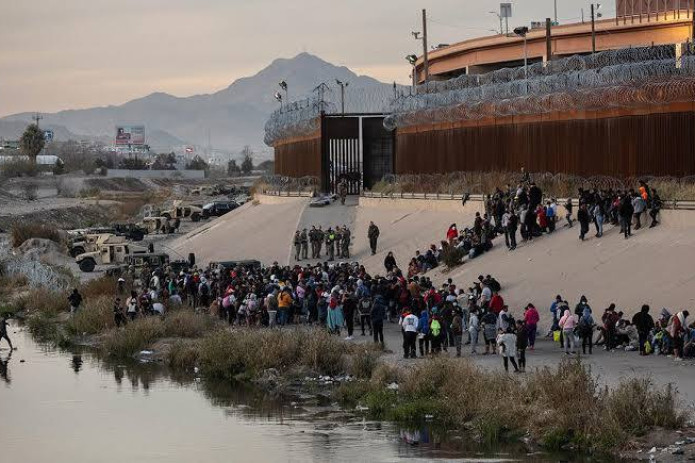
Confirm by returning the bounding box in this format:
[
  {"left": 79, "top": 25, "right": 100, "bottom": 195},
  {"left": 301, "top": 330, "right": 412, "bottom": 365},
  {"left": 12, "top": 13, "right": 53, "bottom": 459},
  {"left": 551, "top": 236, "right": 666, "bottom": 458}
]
[{"left": 265, "top": 46, "right": 695, "bottom": 142}]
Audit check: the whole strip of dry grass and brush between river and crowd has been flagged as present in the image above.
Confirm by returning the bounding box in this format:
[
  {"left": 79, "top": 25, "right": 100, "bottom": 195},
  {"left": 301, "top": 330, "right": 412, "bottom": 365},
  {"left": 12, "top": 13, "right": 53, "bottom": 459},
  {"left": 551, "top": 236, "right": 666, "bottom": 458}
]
[{"left": 4, "top": 280, "right": 695, "bottom": 460}]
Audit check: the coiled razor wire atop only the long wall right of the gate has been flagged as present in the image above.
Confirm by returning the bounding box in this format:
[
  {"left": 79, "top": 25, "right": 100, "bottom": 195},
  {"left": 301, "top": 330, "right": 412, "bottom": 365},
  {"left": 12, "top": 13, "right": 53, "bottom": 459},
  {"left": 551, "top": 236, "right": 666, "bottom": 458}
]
[{"left": 384, "top": 47, "right": 695, "bottom": 130}]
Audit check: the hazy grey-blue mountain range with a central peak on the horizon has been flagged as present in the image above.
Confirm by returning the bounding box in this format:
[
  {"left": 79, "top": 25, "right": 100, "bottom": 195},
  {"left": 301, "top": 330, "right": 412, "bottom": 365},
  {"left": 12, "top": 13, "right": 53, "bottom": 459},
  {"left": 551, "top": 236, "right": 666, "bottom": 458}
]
[{"left": 0, "top": 53, "right": 400, "bottom": 158}]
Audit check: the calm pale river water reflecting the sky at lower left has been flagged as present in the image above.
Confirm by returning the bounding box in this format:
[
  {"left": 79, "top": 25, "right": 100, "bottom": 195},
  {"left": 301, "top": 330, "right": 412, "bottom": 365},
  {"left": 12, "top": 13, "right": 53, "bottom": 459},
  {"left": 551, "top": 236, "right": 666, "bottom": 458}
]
[{"left": 0, "top": 327, "right": 592, "bottom": 463}]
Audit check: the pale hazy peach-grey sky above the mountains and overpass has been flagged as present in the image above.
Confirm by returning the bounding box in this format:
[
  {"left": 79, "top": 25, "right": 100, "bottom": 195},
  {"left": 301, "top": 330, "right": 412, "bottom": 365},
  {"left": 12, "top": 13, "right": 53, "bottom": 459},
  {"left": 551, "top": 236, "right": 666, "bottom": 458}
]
[{"left": 0, "top": 0, "right": 614, "bottom": 115}]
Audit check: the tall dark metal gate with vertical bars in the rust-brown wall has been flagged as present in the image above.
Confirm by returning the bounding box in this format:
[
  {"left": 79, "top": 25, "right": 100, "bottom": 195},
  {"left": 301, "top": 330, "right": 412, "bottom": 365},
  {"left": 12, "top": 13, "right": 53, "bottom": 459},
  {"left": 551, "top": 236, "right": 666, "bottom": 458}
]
[{"left": 321, "top": 115, "right": 393, "bottom": 195}]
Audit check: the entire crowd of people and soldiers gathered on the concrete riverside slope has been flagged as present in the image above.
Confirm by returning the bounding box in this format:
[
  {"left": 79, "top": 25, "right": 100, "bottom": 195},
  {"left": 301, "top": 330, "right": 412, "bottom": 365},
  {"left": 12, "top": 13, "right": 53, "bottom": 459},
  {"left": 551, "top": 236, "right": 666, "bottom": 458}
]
[{"left": 10, "top": 172, "right": 684, "bottom": 371}]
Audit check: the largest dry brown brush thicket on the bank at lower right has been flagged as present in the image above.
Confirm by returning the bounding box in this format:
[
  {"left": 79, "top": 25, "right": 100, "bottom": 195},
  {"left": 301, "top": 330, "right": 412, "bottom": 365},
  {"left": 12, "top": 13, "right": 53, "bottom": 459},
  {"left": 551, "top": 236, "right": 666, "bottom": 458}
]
[{"left": 336, "top": 359, "right": 686, "bottom": 452}]
